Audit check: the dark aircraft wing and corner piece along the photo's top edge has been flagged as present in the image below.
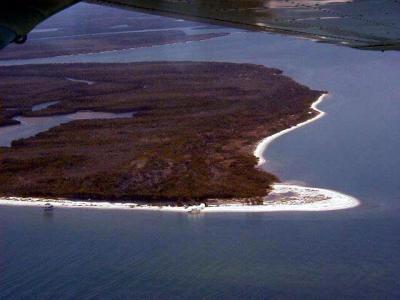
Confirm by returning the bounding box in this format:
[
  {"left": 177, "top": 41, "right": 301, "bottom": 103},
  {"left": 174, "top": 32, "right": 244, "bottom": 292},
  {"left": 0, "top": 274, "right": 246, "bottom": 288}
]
[{"left": 0, "top": 0, "right": 400, "bottom": 50}]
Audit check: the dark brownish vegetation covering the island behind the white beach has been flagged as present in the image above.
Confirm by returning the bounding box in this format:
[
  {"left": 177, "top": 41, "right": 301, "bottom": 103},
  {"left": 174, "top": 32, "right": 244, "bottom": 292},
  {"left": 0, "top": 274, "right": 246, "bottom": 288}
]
[{"left": 0, "top": 62, "right": 321, "bottom": 201}]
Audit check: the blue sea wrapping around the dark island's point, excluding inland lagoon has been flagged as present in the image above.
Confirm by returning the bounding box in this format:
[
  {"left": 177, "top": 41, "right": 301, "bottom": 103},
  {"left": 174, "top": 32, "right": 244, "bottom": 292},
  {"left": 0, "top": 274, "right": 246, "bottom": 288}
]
[{"left": 0, "top": 5, "right": 400, "bottom": 299}]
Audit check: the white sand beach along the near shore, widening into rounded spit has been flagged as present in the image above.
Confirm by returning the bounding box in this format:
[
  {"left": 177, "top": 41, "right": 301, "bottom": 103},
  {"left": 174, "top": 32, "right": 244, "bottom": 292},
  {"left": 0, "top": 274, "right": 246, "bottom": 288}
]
[{"left": 0, "top": 184, "right": 360, "bottom": 213}]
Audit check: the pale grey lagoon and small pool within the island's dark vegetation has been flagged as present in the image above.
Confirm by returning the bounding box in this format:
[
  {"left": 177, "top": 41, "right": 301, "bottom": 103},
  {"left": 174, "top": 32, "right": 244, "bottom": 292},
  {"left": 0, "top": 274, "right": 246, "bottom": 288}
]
[{"left": 0, "top": 110, "right": 133, "bottom": 147}]
